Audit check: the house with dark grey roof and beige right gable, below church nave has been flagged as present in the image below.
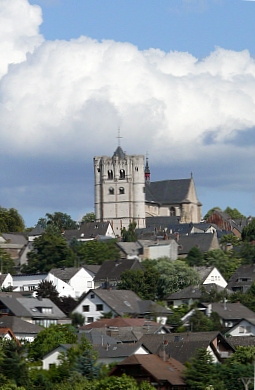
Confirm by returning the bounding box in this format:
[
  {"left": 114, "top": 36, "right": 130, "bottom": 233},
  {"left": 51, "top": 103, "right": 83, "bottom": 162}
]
[{"left": 177, "top": 233, "right": 220, "bottom": 257}]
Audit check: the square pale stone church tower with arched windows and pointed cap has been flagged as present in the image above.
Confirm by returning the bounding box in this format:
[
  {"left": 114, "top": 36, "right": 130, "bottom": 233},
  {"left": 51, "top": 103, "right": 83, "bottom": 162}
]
[{"left": 94, "top": 145, "right": 146, "bottom": 235}]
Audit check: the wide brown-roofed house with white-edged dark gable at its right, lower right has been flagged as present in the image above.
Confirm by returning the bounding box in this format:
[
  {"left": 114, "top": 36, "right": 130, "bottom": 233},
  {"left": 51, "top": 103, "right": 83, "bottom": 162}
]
[{"left": 139, "top": 331, "right": 235, "bottom": 364}]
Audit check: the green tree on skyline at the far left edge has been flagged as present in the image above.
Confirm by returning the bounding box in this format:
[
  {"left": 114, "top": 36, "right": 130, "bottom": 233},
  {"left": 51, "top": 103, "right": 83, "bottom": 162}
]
[{"left": 0, "top": 207, "right": 25, "bottom": 233}]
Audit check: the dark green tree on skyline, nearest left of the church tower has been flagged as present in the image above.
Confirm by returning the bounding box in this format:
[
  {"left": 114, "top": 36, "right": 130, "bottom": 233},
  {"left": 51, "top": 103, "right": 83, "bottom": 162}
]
[{"left": 37, "top": 211, "right": 79, "bottom": 233}]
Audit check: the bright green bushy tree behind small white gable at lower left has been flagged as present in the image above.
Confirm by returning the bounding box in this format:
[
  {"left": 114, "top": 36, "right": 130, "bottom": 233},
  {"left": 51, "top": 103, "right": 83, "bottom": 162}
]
[{"left": 28, "top": 325, "right": 77, "bottom": 360}]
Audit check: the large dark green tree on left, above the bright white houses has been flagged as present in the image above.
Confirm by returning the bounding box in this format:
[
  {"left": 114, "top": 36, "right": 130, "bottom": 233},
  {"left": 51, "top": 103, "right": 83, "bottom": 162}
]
[{"left": 21, "top": 233, "right": 76, "bottom": 273}]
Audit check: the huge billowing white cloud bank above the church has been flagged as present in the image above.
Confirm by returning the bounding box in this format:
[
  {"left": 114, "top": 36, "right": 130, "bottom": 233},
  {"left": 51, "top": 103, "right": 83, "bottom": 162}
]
[{"left": 0, "top": 0, "right": 255, "bottom": 168}]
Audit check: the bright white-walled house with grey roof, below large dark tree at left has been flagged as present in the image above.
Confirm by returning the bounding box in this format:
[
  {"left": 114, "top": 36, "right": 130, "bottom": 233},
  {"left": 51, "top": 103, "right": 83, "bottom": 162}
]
[{"left": 46, "top": 267, "right": 94, "bottom": 298}]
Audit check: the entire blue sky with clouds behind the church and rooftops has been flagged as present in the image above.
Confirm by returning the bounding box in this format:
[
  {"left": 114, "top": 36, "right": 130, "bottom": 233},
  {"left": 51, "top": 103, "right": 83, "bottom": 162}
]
[{"left": 0, "top": 0, "right": 255, "bottom": 227}]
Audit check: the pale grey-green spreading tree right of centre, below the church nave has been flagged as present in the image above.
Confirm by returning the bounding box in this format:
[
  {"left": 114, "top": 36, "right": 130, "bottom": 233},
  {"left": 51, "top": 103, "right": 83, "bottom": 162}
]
[{"left": 155, "top": 258, "right": 200, "bottom": 300}]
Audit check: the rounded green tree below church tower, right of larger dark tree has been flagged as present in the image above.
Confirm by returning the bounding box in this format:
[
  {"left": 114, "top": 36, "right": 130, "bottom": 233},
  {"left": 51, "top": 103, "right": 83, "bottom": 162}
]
[{"left": 77, "top": 240, "right": 119, "bottom": 264}]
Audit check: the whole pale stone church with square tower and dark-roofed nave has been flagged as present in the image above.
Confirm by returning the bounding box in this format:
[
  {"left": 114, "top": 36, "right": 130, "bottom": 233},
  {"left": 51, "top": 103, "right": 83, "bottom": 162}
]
[{"left": 94, "top": 145, "right": 202, "bottom": 235}]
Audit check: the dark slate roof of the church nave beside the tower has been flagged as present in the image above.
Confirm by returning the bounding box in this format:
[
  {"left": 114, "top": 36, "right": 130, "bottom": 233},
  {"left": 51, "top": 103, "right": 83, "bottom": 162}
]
[{"left": 145, "top": 179, "right": 192, "bottom": 204}]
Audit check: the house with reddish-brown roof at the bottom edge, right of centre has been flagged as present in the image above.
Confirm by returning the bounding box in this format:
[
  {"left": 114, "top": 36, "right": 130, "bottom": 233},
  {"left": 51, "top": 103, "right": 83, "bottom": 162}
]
[{"left": 109, "top": 354, "right": 187, "bottom": 390}]
